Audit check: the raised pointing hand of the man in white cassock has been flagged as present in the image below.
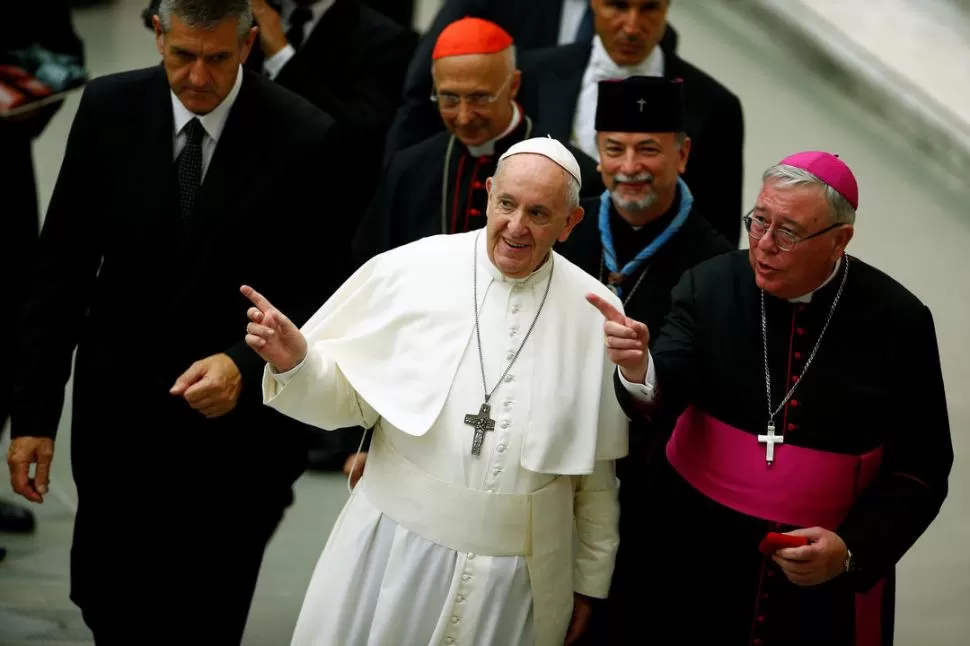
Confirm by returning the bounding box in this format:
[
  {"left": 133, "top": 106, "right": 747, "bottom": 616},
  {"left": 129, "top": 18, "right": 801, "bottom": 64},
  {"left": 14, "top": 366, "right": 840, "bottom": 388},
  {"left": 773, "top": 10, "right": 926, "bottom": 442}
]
[{"left": 240, "top": 285, "right": 307, "bottom": 372}]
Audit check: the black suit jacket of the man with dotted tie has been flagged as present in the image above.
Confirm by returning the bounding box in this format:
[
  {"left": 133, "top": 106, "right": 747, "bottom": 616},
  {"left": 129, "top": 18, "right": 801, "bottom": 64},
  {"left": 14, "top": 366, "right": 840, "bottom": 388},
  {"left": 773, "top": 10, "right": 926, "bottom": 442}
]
[{"left": 13, "top": 66, "right": 346, "bottom": 502}]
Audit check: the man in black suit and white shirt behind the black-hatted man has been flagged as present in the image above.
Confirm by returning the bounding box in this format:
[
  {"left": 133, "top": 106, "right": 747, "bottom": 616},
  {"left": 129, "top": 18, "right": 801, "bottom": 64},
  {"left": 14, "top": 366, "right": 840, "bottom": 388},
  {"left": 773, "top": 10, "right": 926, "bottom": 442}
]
[{"left": 520, "top": 0, "right": 744, "bottom": 246}]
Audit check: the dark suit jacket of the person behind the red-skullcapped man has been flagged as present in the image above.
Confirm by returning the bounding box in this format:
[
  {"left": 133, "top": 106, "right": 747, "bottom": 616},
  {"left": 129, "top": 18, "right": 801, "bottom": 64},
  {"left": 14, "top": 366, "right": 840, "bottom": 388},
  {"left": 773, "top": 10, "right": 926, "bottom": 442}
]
[{"left": 384, "top": 0, "right": 677, "bottom": 160}]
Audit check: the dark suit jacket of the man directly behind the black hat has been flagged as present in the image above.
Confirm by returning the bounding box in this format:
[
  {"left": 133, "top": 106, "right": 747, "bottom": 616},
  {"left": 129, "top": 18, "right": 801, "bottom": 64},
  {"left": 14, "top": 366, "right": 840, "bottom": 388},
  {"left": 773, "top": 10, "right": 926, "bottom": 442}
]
[{"left": 519, "top": 43, "right": 744, "bottom": 246}]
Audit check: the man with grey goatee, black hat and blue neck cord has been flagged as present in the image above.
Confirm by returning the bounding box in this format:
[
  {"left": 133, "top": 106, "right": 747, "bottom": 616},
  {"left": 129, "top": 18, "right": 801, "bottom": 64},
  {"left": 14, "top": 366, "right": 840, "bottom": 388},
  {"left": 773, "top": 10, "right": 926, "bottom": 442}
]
[{"left": 559, "top": 76, "right": 733, "bottom": 645}]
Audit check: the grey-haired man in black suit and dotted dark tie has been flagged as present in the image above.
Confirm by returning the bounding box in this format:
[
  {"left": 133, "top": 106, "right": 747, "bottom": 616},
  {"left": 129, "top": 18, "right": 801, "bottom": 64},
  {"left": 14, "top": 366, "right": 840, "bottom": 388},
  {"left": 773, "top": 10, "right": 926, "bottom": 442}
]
[{"left": 9, "top": 0, "right": 346, "bottom": 644}]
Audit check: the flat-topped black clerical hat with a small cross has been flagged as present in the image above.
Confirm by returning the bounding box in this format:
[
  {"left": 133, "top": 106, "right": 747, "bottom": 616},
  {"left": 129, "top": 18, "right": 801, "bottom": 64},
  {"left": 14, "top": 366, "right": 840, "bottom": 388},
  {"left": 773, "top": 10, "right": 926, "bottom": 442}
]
[{"left": 596, "top": 76, "right": 684, "bottom": 132}]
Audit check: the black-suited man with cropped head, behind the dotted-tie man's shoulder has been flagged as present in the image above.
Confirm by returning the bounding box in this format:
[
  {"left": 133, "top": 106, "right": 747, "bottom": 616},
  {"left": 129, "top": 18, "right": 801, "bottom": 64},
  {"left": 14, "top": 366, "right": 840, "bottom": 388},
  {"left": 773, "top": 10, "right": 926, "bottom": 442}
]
[{"left": 144, "top": 0, "right": 417, "bottom": 471}]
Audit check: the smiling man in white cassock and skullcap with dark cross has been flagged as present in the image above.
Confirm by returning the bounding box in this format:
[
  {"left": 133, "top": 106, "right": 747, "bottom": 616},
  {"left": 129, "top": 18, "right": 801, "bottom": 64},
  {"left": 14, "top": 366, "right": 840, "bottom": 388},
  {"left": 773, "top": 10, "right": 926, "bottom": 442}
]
[{"left": 242, "top": 139, "right": 627, "bottom": 646}]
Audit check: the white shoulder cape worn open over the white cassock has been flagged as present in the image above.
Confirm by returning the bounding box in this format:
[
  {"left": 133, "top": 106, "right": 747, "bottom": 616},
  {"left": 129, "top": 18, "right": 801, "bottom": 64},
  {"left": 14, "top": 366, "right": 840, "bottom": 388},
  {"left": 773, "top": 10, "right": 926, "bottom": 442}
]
[{"left": 292, "top": 231, "right": 627, "bottom": 475}]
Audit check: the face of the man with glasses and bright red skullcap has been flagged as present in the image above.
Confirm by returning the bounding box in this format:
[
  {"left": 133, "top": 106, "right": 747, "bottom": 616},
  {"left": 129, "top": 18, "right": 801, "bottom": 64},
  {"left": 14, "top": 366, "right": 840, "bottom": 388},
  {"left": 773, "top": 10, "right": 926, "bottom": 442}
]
[{"left": 432, "top": 46, "right": 521, "bottom": 146}]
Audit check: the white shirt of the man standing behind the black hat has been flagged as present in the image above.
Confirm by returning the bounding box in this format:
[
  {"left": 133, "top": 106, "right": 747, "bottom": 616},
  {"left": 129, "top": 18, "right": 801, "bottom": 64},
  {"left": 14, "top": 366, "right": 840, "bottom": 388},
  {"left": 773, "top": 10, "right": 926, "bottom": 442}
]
[{"left": 571, "top": 36, "right": 664, "bottom": 161}]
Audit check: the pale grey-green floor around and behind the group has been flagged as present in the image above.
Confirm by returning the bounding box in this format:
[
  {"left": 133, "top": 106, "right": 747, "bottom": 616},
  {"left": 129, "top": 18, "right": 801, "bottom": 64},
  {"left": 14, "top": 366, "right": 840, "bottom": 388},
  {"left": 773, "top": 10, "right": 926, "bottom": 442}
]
[{"left": 0, "top": 0, "right": 970, "bottom": 646}]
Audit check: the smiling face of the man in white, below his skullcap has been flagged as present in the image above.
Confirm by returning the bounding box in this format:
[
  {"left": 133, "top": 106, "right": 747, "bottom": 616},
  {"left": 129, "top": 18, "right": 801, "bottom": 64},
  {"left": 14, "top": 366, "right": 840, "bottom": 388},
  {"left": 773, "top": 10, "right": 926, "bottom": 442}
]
[{"left": 485, "top": 153, "right": 583, "bottom": 278}]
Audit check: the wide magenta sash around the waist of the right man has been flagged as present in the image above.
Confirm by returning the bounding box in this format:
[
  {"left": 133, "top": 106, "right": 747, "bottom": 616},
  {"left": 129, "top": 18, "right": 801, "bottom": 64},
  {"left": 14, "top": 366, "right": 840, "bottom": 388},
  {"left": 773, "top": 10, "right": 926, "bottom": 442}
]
[{"left": 667, "top": 406, "right": 885, "bottom": 646}]
